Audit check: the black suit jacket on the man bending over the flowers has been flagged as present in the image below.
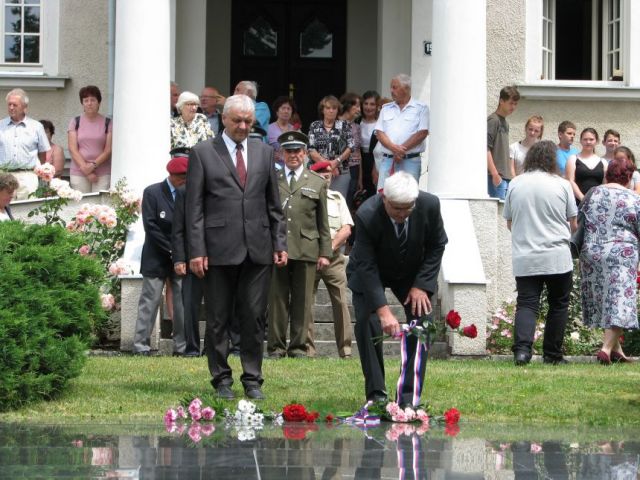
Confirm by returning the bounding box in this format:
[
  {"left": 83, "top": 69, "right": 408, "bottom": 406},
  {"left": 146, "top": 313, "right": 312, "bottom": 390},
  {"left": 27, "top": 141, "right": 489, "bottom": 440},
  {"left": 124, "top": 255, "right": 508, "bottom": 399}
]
[{"left": 347, "top": 192, "right": 448, "bottom": 310}]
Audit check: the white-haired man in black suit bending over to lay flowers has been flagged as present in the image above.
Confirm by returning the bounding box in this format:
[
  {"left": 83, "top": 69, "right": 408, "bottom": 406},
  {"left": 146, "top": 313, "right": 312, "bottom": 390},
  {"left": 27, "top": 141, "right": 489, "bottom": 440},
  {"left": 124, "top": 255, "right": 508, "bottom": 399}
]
[{"left": 347, "top": 172, "right": 447, "bottom": 406}]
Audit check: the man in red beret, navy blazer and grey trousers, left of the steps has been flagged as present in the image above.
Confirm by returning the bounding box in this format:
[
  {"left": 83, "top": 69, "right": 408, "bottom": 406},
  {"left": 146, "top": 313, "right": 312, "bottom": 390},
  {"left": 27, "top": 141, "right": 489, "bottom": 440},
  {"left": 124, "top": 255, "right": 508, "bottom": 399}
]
[{"left": 133, "top": 157, "right": 187, "bottom": 355}]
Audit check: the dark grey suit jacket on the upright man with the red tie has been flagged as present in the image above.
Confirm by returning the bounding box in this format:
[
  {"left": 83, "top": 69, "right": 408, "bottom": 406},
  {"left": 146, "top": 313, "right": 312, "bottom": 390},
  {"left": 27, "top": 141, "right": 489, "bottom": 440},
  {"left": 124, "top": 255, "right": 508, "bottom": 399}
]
[{"left": 185, "top": 135, "right": 287, "bottom": 266}]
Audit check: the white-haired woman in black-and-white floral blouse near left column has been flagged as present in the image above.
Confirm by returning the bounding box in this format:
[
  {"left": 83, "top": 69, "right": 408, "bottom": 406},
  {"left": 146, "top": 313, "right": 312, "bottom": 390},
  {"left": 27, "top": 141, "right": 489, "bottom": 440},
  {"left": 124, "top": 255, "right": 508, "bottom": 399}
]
[{"left": 171, "top": 92, "right": 213, "bottom": 150}]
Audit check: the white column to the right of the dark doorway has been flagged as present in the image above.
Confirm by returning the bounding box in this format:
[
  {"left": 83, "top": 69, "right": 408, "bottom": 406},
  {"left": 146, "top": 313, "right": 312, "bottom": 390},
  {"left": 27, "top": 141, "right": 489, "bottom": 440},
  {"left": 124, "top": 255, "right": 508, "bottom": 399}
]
[{"left": 428, "top": 0, "right": 487, "bottom": 199}]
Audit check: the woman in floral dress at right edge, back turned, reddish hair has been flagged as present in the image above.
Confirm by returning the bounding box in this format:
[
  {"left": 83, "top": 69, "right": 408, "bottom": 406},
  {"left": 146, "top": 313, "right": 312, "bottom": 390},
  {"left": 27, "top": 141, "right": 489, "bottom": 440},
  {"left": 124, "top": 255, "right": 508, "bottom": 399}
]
[{"left": 580, "top": 157, "right": 640, "bottom": 365}]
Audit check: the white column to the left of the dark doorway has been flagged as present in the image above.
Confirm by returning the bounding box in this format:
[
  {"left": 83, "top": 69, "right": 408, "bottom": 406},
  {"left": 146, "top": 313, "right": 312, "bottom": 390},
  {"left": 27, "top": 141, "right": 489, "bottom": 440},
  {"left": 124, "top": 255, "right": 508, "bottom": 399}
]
[{"left": 111, "top": 0, "right": 170, "bottom": 193}]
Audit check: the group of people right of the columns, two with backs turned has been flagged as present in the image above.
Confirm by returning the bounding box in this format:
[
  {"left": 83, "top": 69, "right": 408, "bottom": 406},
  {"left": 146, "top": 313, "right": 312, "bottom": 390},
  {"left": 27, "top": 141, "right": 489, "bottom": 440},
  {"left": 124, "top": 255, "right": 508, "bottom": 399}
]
[{"left": 500, "top": 87, "right": 640, "bottom": 365}]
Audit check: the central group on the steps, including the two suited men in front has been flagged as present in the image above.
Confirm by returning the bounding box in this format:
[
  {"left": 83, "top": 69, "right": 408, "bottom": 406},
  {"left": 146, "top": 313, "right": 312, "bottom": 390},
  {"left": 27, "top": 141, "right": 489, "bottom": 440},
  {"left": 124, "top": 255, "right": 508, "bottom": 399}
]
[{"left": 129, "top": 75, "right": 440, "bottom": 405}]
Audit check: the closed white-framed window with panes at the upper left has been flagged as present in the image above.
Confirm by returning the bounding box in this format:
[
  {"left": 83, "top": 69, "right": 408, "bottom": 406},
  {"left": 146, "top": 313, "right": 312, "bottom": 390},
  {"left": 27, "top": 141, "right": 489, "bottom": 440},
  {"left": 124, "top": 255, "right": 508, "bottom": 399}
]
[{"left": 2, "top": 0, "right": 42, "bottom": 65}]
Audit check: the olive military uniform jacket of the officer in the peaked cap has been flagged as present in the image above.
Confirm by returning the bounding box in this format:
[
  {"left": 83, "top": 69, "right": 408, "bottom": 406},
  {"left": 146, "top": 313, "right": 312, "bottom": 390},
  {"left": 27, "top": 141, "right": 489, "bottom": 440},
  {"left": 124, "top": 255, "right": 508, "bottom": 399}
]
[{"left": 278, "top": 168, "right": 333, "bottom": 263}]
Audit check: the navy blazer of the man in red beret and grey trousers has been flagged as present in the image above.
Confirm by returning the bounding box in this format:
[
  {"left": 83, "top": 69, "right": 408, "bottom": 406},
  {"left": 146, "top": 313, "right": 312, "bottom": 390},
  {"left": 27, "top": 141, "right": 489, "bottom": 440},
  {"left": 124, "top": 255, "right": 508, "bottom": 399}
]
[{"left": 140, "top": 180, "right": 174, "bottom": 277}]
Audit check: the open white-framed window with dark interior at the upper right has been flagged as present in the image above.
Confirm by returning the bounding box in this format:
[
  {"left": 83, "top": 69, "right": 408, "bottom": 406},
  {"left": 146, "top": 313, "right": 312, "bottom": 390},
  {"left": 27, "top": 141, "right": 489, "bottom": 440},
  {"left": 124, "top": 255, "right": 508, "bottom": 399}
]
[{"left": 540, "top": 0, "right": 624, "bottom": 81}]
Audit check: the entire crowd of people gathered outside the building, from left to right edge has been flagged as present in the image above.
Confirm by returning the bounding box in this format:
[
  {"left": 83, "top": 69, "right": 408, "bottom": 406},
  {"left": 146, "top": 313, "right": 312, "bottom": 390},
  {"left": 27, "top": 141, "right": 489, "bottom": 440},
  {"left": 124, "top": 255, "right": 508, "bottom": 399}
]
[{"left": 0, "top": 74, "right": 640, "bottom": 405}]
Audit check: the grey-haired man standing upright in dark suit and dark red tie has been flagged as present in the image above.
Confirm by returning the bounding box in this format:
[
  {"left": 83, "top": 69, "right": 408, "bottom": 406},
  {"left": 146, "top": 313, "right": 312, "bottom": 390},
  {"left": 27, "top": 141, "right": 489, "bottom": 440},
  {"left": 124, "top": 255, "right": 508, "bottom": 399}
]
[{"left": 186, "top": 95, "right": 287, "bottom": 399}]
